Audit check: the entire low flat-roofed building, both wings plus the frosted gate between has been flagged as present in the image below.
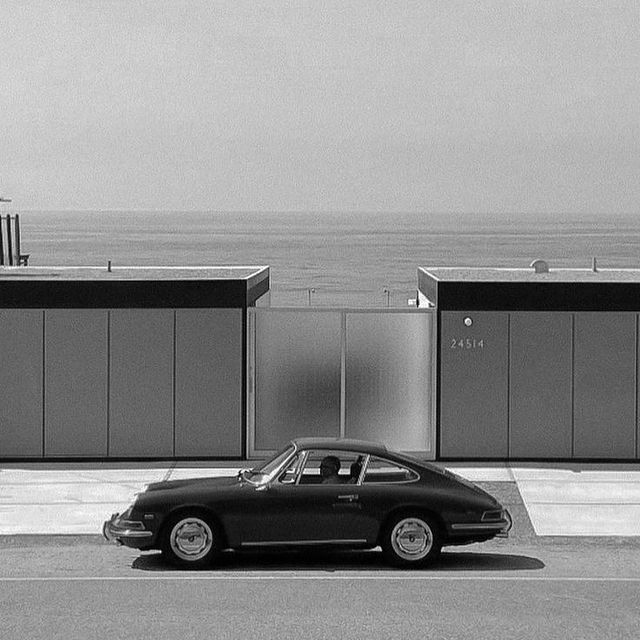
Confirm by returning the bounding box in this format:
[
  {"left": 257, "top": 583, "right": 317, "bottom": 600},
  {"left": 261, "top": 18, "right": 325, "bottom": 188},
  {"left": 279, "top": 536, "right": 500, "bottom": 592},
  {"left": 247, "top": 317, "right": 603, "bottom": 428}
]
[{"left": 0, "top": 261, "right": 640, "bottom": 461}]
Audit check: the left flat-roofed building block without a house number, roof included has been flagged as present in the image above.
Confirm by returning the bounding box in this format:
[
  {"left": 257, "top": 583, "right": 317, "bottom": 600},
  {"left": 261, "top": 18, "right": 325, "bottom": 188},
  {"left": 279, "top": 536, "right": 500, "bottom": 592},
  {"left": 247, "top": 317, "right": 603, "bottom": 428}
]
[{"left": 0, "top": 266, "right": 269, "bottom": 459}]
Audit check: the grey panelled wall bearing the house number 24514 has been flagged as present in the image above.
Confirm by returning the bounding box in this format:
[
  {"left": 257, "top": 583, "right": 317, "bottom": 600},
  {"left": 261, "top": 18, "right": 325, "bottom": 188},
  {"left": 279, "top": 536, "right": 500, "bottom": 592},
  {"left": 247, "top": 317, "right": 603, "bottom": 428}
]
[{"left": 439, "top": 311, "right": 640, "bottom": 460}]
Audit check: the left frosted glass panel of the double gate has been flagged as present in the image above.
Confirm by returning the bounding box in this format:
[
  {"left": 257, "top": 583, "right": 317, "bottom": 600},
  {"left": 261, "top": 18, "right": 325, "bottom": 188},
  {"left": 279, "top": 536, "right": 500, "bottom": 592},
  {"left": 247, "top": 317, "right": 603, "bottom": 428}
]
[{"left": 254, "top": 309, "right": 341, "bottom": 451}]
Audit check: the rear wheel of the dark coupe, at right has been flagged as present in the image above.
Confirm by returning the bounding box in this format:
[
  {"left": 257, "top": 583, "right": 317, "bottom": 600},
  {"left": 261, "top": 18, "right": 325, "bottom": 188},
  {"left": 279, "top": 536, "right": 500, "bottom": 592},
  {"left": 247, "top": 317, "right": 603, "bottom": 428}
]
[{"left": 381, "top": 513, "right": 442, "bottom": 568}]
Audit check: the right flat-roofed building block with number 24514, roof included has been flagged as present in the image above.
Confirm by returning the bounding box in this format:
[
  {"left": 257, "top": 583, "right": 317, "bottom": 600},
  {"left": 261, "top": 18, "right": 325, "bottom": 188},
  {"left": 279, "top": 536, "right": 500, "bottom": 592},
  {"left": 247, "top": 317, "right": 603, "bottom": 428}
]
[{"left": 418, "top": 261, "right": 640, "bottom": 460}]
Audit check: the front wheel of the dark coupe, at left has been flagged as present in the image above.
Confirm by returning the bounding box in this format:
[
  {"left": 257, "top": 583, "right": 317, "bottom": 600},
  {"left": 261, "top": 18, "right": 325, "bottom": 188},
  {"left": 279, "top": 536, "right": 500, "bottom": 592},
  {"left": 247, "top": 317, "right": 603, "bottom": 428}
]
[{"left": 162, "top": 513, "right": 221, "bottom": 569}]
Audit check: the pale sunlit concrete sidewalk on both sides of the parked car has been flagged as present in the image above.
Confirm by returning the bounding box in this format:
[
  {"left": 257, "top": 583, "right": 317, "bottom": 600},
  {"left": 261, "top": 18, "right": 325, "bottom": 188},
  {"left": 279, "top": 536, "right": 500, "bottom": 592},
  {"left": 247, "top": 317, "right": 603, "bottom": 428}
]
[{"left": 0, "top": 461, "right": 640, "bottom": 536}]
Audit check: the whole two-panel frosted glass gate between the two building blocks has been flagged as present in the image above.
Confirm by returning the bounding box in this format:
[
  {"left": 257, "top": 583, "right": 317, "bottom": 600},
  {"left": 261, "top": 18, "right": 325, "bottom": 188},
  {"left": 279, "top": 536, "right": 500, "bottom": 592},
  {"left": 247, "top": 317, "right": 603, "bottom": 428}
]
[{"left": 247, "top": 307, "right": 436, "bottom": 458}]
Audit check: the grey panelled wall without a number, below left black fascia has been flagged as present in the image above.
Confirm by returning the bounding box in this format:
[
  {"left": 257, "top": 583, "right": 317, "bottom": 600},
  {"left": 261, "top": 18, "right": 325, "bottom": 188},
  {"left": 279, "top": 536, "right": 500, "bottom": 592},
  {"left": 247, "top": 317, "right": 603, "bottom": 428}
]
[{"left": 0, "top": 309, "right": 243, "bottom": 458}]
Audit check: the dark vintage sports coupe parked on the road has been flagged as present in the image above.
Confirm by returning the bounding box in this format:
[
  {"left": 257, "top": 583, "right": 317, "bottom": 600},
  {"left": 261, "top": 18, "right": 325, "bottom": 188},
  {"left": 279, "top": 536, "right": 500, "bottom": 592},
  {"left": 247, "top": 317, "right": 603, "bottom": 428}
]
[{"left": 103, "top": 438, "right": 511, "bottom": 567}]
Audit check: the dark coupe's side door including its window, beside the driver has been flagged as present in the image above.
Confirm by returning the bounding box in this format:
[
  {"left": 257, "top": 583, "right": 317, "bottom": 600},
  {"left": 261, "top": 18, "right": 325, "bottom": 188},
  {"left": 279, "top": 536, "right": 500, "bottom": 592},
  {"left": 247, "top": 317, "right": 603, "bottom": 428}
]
[{"left": 236, "top": 450, "right": 375, "bottom": 546}]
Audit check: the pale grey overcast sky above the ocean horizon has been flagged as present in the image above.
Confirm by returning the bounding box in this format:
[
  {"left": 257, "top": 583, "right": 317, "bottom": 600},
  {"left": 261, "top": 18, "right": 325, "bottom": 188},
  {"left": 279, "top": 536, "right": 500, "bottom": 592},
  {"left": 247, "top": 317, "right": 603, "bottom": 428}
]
[{"left": 0, "top": 0, "right": 640, "bottom": 214}]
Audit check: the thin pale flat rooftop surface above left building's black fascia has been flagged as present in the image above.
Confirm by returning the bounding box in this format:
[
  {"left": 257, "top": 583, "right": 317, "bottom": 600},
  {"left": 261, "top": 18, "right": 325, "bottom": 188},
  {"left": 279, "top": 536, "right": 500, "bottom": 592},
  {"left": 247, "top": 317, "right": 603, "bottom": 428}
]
[{"left": 0, "top": 265, "right": 269, "bottom": 281}]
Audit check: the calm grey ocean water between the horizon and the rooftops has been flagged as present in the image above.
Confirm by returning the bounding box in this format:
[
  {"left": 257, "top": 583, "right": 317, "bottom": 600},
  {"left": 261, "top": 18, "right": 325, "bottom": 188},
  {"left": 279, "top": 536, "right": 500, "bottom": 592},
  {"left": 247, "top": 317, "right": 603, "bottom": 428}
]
[{"left": 19, "top": 211, "right": 640, "bottom": 307}]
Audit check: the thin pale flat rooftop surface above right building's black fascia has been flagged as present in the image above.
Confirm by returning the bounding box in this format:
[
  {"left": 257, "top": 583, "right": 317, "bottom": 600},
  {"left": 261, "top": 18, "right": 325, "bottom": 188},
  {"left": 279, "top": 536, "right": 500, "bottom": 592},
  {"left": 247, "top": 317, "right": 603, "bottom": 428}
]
[{"left": 419, "top": 267, "right": 640, "bottom": 282}]
